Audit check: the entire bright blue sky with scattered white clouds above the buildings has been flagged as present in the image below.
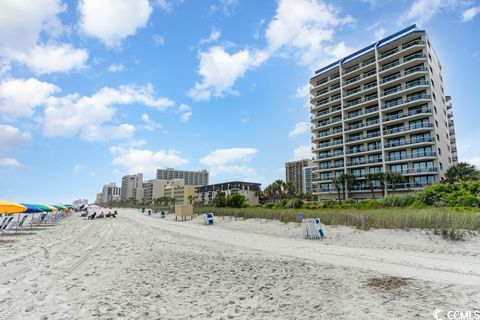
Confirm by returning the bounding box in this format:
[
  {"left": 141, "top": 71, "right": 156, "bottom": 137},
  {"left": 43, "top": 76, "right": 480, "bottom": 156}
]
[{"left": 0, "top": 0, "right": 480, "bottom": 202}]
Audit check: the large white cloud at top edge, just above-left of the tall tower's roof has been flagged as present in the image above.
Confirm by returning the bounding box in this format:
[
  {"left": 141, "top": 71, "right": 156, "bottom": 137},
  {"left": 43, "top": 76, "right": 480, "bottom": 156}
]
[{"left": 266, "top": 0, "right": 354, "bottom": 65}]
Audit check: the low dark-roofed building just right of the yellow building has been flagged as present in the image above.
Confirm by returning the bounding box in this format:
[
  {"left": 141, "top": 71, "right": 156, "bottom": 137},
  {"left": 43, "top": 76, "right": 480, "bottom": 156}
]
[{"left": 196, "top": 181, "right": 260, "bottom": 205}]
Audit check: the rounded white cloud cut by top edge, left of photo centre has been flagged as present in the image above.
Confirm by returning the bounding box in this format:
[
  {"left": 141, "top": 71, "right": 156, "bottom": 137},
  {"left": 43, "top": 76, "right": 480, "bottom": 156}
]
[{"left": 78, "top": 0, "right": 152, "bottom": 47}]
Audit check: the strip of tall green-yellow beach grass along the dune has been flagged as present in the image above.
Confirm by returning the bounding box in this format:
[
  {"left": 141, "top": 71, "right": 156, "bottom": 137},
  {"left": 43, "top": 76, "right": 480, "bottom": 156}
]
[{"left": 195, "top": 207, "right": 480, "bottom": 231}]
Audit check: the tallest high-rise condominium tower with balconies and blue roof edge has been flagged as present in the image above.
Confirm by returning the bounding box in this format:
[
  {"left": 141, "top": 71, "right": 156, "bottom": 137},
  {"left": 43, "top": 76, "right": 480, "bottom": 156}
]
[{"left": 310, "top": 25, "right": 456, "bottom": 199}]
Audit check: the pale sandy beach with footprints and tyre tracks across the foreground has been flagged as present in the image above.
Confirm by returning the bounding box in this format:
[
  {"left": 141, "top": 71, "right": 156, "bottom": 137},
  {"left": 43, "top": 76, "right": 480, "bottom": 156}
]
[{"left": 0, "top": 209, "right": 480, "bottom": 319}]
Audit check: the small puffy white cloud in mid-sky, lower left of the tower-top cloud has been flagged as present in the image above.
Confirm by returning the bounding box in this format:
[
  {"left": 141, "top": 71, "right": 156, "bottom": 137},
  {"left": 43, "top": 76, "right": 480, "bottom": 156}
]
[{"left": 188, "top": 46, "right": 267, "bottom": 101}]
